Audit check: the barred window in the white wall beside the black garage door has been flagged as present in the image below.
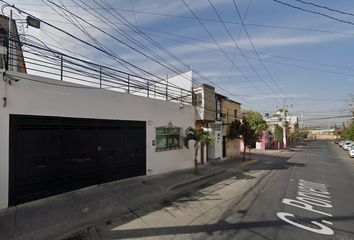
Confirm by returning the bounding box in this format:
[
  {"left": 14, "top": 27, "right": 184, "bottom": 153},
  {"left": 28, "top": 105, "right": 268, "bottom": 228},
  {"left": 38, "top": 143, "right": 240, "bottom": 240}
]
[{"left": 156, "top": 128, "right": 182, "bottom": 152}]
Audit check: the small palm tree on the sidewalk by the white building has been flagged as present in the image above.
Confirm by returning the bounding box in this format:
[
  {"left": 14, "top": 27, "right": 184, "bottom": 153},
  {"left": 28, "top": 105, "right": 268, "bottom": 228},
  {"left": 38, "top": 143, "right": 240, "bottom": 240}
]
[{"left": 183, "top": 127, "right": 215, "bottom": 173}]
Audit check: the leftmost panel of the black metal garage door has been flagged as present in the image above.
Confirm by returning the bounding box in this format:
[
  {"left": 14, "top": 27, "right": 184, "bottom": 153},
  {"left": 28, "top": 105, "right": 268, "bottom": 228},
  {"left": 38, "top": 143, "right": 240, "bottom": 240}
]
[{"left": 16, "top": 131, "right": 62, "bottom": 204}]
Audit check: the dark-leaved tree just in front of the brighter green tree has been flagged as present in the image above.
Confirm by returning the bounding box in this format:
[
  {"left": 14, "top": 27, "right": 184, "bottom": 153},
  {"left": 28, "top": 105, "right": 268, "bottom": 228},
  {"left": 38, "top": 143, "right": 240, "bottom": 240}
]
[{"left": 228, "top": 118, "right": 258, "bottom": 161}]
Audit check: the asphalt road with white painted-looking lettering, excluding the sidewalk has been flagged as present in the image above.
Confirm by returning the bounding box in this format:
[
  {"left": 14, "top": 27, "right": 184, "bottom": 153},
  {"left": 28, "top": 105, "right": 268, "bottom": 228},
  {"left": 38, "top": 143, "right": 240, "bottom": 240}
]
[{"left": 66, "top": 140, "right": 354, "bottom": 240}]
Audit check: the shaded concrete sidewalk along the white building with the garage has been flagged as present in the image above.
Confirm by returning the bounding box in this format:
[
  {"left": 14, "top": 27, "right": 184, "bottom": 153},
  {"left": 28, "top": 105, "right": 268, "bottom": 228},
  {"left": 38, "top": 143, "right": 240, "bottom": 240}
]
[{"left": 0, "top": 142, "right": 298, "bottom": 240}]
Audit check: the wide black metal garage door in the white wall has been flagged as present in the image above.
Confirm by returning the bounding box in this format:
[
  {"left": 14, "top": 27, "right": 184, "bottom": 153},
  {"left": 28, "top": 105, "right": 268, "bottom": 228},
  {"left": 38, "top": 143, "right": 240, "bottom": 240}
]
[{"left": 9, "top": 115, "right": 146, "bottom": 206}]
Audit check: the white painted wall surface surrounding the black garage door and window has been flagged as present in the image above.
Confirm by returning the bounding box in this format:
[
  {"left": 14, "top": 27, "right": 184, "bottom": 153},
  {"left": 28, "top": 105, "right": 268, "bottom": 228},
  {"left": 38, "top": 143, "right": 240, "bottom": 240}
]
[{"left": 0, "top": 71, "right": 195, "bottom": 208}]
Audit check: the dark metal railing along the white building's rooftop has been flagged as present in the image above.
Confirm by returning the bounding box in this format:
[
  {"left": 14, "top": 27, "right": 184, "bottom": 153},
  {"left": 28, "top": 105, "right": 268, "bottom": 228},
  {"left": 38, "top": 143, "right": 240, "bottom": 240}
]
[{"left": 3, "top": 38, "right": 192, "bottom": 104}]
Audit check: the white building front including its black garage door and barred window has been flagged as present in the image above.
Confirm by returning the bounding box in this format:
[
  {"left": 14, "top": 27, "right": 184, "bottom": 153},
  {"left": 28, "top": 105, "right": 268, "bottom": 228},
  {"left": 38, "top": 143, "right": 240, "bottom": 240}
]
[{"left": 0, "top": 71, "right": 195, "bottom": 208}]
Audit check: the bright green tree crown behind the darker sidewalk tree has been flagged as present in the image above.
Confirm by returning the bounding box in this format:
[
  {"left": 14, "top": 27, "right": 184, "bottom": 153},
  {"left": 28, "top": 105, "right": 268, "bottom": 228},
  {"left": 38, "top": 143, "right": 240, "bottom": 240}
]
[{"left": 242, "top": 110, "right": 269, "bottom": 142}]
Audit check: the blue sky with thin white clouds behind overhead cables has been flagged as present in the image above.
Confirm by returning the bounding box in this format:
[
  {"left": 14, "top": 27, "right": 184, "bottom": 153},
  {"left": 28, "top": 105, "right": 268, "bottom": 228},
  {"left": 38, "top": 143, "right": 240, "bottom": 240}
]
[{"left": 0, "top": 0, "right": 354, "bottom": 128}]
